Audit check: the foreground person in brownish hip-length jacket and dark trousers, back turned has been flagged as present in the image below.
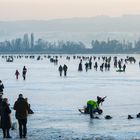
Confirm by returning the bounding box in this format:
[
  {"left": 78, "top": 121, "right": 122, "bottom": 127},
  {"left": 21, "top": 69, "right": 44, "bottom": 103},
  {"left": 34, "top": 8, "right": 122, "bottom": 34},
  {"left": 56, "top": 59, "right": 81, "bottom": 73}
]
[{"left": 14, "top": 94, "right": 29, "bottom": 138}]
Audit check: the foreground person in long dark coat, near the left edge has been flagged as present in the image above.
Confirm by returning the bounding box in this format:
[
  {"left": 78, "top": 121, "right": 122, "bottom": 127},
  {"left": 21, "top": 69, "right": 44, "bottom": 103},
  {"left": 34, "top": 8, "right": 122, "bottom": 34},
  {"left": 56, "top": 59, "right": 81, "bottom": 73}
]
[{"left": 1, "top": 98, "right": 12, "bottom": 138}]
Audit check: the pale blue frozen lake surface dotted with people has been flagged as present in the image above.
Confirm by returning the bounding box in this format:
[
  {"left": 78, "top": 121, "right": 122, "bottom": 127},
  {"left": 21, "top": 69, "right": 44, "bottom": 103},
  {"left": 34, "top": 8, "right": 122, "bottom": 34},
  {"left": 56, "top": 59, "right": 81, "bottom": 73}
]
[{"left": 0, "top": 55, "right": 140, "bottom": 140}]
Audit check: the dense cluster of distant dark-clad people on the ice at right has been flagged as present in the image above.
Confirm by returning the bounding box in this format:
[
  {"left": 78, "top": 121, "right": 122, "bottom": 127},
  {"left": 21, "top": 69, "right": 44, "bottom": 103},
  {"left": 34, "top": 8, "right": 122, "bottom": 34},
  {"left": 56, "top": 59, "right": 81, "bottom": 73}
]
[{"left": 78, "top": 57, "right": 135, "bottom": 72}]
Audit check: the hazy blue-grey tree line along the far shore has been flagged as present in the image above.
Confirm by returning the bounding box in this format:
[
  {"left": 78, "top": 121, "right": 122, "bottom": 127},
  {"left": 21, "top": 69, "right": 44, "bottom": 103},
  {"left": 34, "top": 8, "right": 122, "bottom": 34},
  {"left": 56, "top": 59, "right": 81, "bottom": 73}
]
[{"left": 0, "top": 34, "right": 140, "bottom": 54}]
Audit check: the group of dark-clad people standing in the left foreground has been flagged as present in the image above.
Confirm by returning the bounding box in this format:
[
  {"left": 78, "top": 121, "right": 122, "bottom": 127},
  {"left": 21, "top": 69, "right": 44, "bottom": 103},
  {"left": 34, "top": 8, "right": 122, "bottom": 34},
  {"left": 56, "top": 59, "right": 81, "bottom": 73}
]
[{"left": 0, "top": 80, "right": 34, "bottom": 138}]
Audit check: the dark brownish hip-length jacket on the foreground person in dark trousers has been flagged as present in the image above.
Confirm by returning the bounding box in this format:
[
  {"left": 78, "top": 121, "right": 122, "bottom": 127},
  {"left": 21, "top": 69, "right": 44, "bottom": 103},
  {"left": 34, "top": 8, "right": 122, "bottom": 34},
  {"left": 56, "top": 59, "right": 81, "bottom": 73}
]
[{"left": 14, "top": 98, "right": 29, "bottom": 119}]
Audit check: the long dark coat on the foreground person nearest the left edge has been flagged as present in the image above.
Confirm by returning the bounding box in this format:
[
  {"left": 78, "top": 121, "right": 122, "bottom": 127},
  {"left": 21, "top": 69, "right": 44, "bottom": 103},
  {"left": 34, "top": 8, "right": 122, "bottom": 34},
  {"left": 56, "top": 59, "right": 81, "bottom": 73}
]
[{"left": 1, "top": 102, "right": 12, "bottom": 129}]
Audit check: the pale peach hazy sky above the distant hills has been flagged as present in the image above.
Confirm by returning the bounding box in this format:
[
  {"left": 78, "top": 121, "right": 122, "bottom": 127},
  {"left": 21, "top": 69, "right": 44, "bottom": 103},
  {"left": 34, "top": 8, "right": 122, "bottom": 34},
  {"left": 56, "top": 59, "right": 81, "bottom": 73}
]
[{"left": 0, "top": 0, "right": 140, "bottom": 20}]
